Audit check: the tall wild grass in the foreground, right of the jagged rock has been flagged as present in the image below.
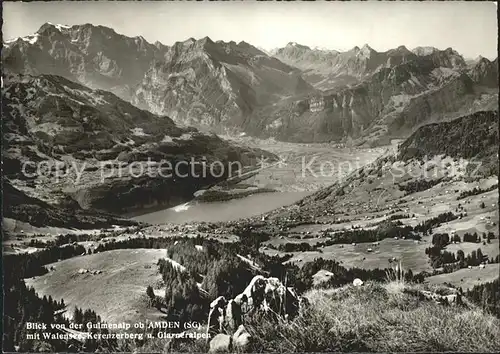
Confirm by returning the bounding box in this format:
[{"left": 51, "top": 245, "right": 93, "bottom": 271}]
[{"left": 246, "top": 283, "right": 500, "bottom": 352}]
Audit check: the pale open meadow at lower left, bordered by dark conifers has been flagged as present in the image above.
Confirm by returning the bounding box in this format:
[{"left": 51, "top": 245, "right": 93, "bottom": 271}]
[{"left": 26, "top": 249, "right": 166, "bottom": 323}]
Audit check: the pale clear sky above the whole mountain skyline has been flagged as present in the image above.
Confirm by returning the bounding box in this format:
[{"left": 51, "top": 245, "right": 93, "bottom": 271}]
[{"left": 2, "top": 1, "right": 497, "bottom": 59}]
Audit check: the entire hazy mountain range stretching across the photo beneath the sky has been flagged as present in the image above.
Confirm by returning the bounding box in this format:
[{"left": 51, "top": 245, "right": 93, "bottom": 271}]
[{"left": 3, "top": 24, "right": 498, "bottom": 145}]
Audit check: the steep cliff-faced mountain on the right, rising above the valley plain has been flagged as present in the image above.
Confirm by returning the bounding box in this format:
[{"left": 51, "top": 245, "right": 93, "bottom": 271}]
[{"left": 249, "top": 52, "right": 498, "bottom": 145}]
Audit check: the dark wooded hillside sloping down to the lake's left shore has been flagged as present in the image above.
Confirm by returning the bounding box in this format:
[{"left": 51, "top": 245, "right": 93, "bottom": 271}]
[{"left": 2, "top": 75, "right": 273, "bottom": 217}]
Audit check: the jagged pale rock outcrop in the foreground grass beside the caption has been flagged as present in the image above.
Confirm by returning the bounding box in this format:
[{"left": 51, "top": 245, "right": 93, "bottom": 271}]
[{"left": 207, "top": 275, "right": 302, "bottom": 351}]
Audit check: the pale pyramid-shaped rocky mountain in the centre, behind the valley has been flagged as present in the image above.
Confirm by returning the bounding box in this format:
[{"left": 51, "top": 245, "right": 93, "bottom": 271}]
[{"left": 132, "top": 37, "right": 314, "bottom": 130}]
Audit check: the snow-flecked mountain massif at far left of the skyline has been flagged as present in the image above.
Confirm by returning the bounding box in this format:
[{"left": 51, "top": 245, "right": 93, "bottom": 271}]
[{"left": 2, "top": 23, "right": 168, "bottom": 100}]
